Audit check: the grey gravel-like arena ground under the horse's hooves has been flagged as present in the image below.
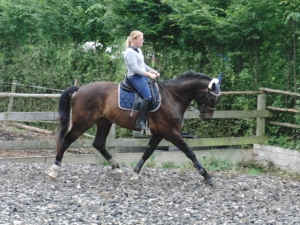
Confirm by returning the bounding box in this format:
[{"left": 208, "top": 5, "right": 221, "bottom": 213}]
[{"left": 0, "top": 163, "right": 300, "bottom": 225}]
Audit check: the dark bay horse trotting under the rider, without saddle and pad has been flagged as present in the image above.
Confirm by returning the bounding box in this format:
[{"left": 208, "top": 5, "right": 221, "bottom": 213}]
[{"left": 49, "top": 71, "right": 221, "bottom": 185}]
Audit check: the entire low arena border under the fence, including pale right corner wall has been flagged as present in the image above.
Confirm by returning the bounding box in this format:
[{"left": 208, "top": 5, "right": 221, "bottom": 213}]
[{"left": 0, "top": 144, "right": 300, "bottom": 173}]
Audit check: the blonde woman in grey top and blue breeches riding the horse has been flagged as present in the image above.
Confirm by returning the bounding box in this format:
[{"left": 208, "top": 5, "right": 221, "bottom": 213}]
[{"left": 124, "top": 30, "right": 160, "bottom": 130}]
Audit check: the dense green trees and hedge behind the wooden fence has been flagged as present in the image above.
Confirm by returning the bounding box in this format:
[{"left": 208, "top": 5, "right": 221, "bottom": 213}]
[{"left": 0, "top": 0, "right": 300, "bottom": 149}]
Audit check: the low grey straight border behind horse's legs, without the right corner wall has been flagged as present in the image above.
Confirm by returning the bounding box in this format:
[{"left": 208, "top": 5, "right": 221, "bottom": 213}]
[{"left": 0, "top": 149, "right": 253, "bottom": 167}]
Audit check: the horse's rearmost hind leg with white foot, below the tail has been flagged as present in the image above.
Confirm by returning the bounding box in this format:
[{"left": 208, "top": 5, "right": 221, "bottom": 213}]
[{"left": 48, "top": 125, "right": 87, "bottom": 180}]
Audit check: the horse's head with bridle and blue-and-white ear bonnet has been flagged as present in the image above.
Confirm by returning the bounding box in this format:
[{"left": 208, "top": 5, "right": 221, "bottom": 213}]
[{"left": 195, "top": 74, "right": 223, "bottom": 120}]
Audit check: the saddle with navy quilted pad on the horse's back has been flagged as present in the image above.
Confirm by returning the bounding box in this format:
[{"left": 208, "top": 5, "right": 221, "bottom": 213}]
[{"left": 118, "top": 77, "right": 161, "bottom": 116}]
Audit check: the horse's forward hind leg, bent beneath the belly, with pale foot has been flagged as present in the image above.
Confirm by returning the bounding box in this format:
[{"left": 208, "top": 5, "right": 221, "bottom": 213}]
[{"left": 93, "top": 118, "right": 124, "bottom": 177}]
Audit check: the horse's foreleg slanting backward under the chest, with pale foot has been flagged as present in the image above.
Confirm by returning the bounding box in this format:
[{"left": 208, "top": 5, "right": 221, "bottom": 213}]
[{"left": 130, "top": 134, "right": 163, "bottom": 181}]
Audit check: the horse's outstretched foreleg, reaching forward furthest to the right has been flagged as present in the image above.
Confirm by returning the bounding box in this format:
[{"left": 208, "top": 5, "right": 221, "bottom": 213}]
[{"left": 170, "top": 136, "right": 213, "bottom": 185}]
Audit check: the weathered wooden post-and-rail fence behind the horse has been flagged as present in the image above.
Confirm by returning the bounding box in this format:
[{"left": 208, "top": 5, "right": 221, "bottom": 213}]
[{"left": 0, "top": 85, "right": 300, "bottom": 150}]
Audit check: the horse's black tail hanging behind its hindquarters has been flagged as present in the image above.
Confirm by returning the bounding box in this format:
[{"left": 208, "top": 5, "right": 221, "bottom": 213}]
[{"left": 57, "top": 86, "right": 79, "bottom": 145}]
